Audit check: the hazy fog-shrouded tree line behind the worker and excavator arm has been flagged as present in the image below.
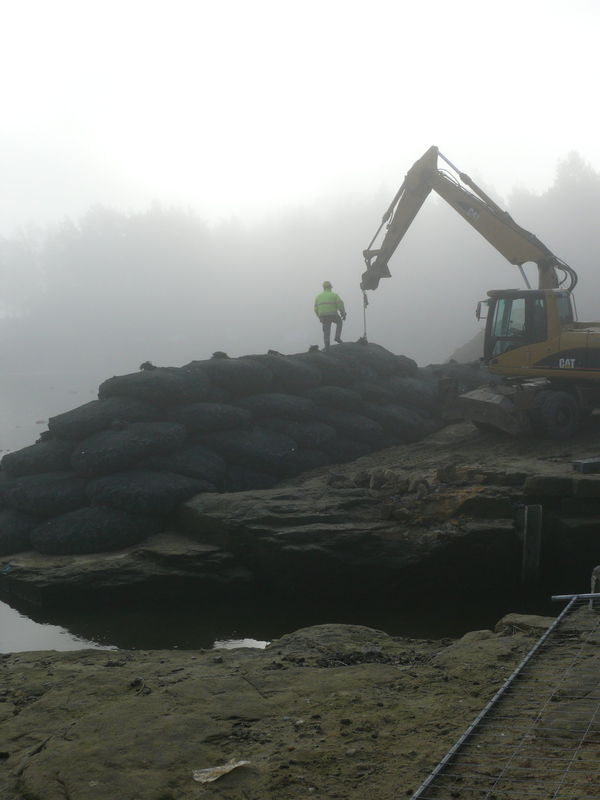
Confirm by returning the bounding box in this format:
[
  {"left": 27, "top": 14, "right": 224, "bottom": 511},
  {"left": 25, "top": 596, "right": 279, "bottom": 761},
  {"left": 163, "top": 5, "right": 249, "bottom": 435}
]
[{"left": 0, "top": 153, "right": 600, "bottom": 374}]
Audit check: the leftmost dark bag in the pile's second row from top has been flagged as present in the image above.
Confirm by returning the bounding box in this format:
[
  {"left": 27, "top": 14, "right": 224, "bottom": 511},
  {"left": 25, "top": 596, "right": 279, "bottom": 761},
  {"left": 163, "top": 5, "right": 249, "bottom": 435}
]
[{"left": 48, "top": 397, "right": 158, "bottom": 439}]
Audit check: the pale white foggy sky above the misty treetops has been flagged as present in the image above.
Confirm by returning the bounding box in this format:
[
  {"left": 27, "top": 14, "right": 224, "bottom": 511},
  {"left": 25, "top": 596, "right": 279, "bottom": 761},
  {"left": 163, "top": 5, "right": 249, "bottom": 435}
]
[{"left": 0, "top": 0, "right": 600, "bottom": 235}]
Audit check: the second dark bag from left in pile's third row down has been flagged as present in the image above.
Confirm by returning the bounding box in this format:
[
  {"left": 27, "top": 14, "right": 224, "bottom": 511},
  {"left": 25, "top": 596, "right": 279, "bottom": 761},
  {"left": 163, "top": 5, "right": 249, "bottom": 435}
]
[{"left": 71, "top": 422, "right": 187, "bottom": 477}]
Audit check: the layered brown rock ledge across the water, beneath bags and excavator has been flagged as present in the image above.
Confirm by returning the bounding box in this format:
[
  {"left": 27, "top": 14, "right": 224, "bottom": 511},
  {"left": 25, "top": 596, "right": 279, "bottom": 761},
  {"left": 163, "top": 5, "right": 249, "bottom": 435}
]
[{"left": 0, "top": 417, "right": 600, "bottom": 607}]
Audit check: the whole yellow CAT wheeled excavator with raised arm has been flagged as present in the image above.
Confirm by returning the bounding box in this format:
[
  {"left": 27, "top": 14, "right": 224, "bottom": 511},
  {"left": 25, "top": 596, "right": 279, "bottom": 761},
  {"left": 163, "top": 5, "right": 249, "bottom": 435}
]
[{"left": 361, "top": 146, "right": 600, "bottom": 439}]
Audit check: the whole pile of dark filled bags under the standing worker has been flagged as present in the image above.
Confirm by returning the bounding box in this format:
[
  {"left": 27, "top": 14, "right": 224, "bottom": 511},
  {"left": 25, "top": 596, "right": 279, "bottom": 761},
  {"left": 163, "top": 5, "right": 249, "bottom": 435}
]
[{"left": 0, "top": 343, "right": 440, "bottom": 555}]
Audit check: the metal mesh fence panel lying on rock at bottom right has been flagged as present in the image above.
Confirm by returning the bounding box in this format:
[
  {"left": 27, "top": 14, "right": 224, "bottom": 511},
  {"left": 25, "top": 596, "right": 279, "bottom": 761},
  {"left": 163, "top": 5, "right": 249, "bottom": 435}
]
[{"left": 411, "top": 594, "right": 600, "bottom": 800}]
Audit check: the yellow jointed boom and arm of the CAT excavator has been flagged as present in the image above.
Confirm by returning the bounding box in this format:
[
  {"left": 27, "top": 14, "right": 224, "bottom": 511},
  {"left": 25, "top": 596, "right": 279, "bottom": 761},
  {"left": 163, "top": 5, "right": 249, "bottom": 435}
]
[{"left": 361, "top": 147, "right": 577, "bottom": 291}]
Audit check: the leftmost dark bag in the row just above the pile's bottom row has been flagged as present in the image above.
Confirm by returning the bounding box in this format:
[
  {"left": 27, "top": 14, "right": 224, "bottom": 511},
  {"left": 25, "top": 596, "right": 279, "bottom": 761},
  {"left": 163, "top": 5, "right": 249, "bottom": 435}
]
[{"left": 3, "top": 472, "right": 87, "bottom": 517}]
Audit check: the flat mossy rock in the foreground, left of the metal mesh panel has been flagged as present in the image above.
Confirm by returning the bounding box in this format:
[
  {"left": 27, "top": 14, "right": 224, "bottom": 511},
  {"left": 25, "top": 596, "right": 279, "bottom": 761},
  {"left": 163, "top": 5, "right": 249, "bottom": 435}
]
[{"left": 0, "top": 615, "right": 551, "bottom": 800}]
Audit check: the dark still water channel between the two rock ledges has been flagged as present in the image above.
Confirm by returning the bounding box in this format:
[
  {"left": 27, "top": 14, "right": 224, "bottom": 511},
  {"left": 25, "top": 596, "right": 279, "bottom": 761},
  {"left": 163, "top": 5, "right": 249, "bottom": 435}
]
[{"left": 0, "top": 595, "right": 558, "bottom": 652}]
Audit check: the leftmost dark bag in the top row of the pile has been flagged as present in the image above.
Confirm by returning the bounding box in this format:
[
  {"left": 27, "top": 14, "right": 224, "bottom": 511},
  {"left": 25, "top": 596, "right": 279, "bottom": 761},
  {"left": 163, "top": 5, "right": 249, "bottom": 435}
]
[{"left": 98, "top": 367, "right": 211, "bottom": 407}]
